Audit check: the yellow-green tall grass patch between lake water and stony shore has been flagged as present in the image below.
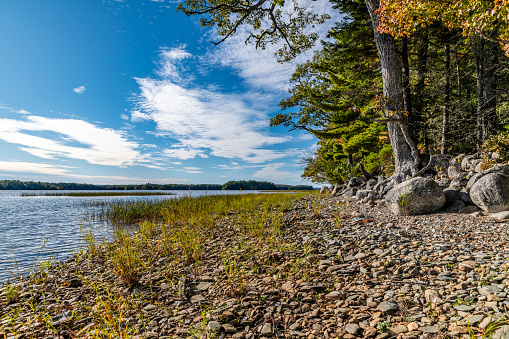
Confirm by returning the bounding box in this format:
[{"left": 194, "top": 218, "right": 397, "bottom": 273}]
[{"left": 85, "top": 194, "right": 302, "bottom": 285}]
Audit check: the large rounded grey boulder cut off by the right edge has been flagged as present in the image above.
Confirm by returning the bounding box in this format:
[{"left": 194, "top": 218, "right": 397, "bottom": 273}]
[{"left": 470, "top": 165, "right": 509, "bottom": 213}]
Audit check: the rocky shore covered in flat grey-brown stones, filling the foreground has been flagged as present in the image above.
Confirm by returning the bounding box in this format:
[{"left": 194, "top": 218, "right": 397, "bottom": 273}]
[{"left": 0, "top": 195, "right": 509, "bottom": 339}]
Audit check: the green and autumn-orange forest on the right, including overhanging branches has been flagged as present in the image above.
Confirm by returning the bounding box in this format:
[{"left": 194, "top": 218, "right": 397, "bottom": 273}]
[{"left": 179, "top": 0, "right": 509, "bottom": 184}]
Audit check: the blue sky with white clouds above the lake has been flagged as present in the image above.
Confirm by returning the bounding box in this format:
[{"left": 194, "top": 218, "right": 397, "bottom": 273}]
[{"left": 0, "top": 0, "right": 338, "bottom": 184}]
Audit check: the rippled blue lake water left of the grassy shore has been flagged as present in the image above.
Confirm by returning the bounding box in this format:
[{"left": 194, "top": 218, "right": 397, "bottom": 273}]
[{"left": 0, "top": 191, "right": 258, "bottom": 282}]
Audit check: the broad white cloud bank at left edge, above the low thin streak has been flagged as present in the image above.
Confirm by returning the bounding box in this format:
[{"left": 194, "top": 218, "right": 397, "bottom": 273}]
[{"left": 0, "top": 116, "right": 146, "bottom": 167}]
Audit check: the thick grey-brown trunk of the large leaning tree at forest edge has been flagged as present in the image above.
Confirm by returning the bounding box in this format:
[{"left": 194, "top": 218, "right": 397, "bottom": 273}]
[{"left": 365, "top": 0, "right": 420, "bottom": 183}]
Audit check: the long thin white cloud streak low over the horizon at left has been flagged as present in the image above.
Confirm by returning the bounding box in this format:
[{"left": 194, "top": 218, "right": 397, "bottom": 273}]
[{"left": 0, "top": 161, "right": 188, "bottom": 184}]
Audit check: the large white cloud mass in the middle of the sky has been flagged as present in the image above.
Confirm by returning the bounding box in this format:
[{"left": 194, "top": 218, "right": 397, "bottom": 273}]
[{"left": 136, "top": 73, "right": 288, "bottom": 163}]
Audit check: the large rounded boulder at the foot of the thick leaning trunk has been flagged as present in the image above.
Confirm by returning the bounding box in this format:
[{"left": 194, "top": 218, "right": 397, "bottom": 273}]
[{"left": 385, "top": 177, "right": 445, "bottom": 215}]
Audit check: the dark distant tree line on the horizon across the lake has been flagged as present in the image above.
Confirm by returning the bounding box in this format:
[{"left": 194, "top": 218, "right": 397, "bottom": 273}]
[{"left": 0, "top": 180, "right": 313, "bottom": 191}]
